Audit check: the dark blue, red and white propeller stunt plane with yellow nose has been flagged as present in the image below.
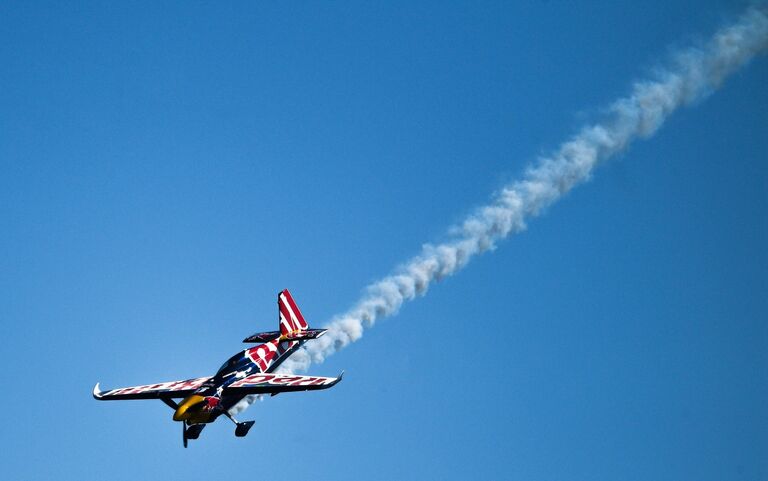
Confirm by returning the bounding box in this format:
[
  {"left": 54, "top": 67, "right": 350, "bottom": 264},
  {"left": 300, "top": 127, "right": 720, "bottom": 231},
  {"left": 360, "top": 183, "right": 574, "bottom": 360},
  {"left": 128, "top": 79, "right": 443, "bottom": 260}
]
[{"left": 93, "top": 289, "right": 344, "bottom": 448}]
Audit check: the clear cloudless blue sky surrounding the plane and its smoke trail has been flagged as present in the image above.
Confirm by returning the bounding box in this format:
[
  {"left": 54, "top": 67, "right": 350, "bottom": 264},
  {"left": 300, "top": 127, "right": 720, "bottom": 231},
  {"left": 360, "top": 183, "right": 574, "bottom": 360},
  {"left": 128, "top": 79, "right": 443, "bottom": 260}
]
[{"left": 0, "top": 0, "right": 768, "bottom": 481}]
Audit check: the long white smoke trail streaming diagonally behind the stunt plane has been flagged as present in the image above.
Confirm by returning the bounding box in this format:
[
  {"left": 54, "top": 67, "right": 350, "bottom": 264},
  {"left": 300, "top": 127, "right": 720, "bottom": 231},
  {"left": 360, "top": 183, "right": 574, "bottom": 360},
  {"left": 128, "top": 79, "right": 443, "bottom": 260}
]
[{"left": 232, "top": 7, "right": 768, "bottom": 412}]
